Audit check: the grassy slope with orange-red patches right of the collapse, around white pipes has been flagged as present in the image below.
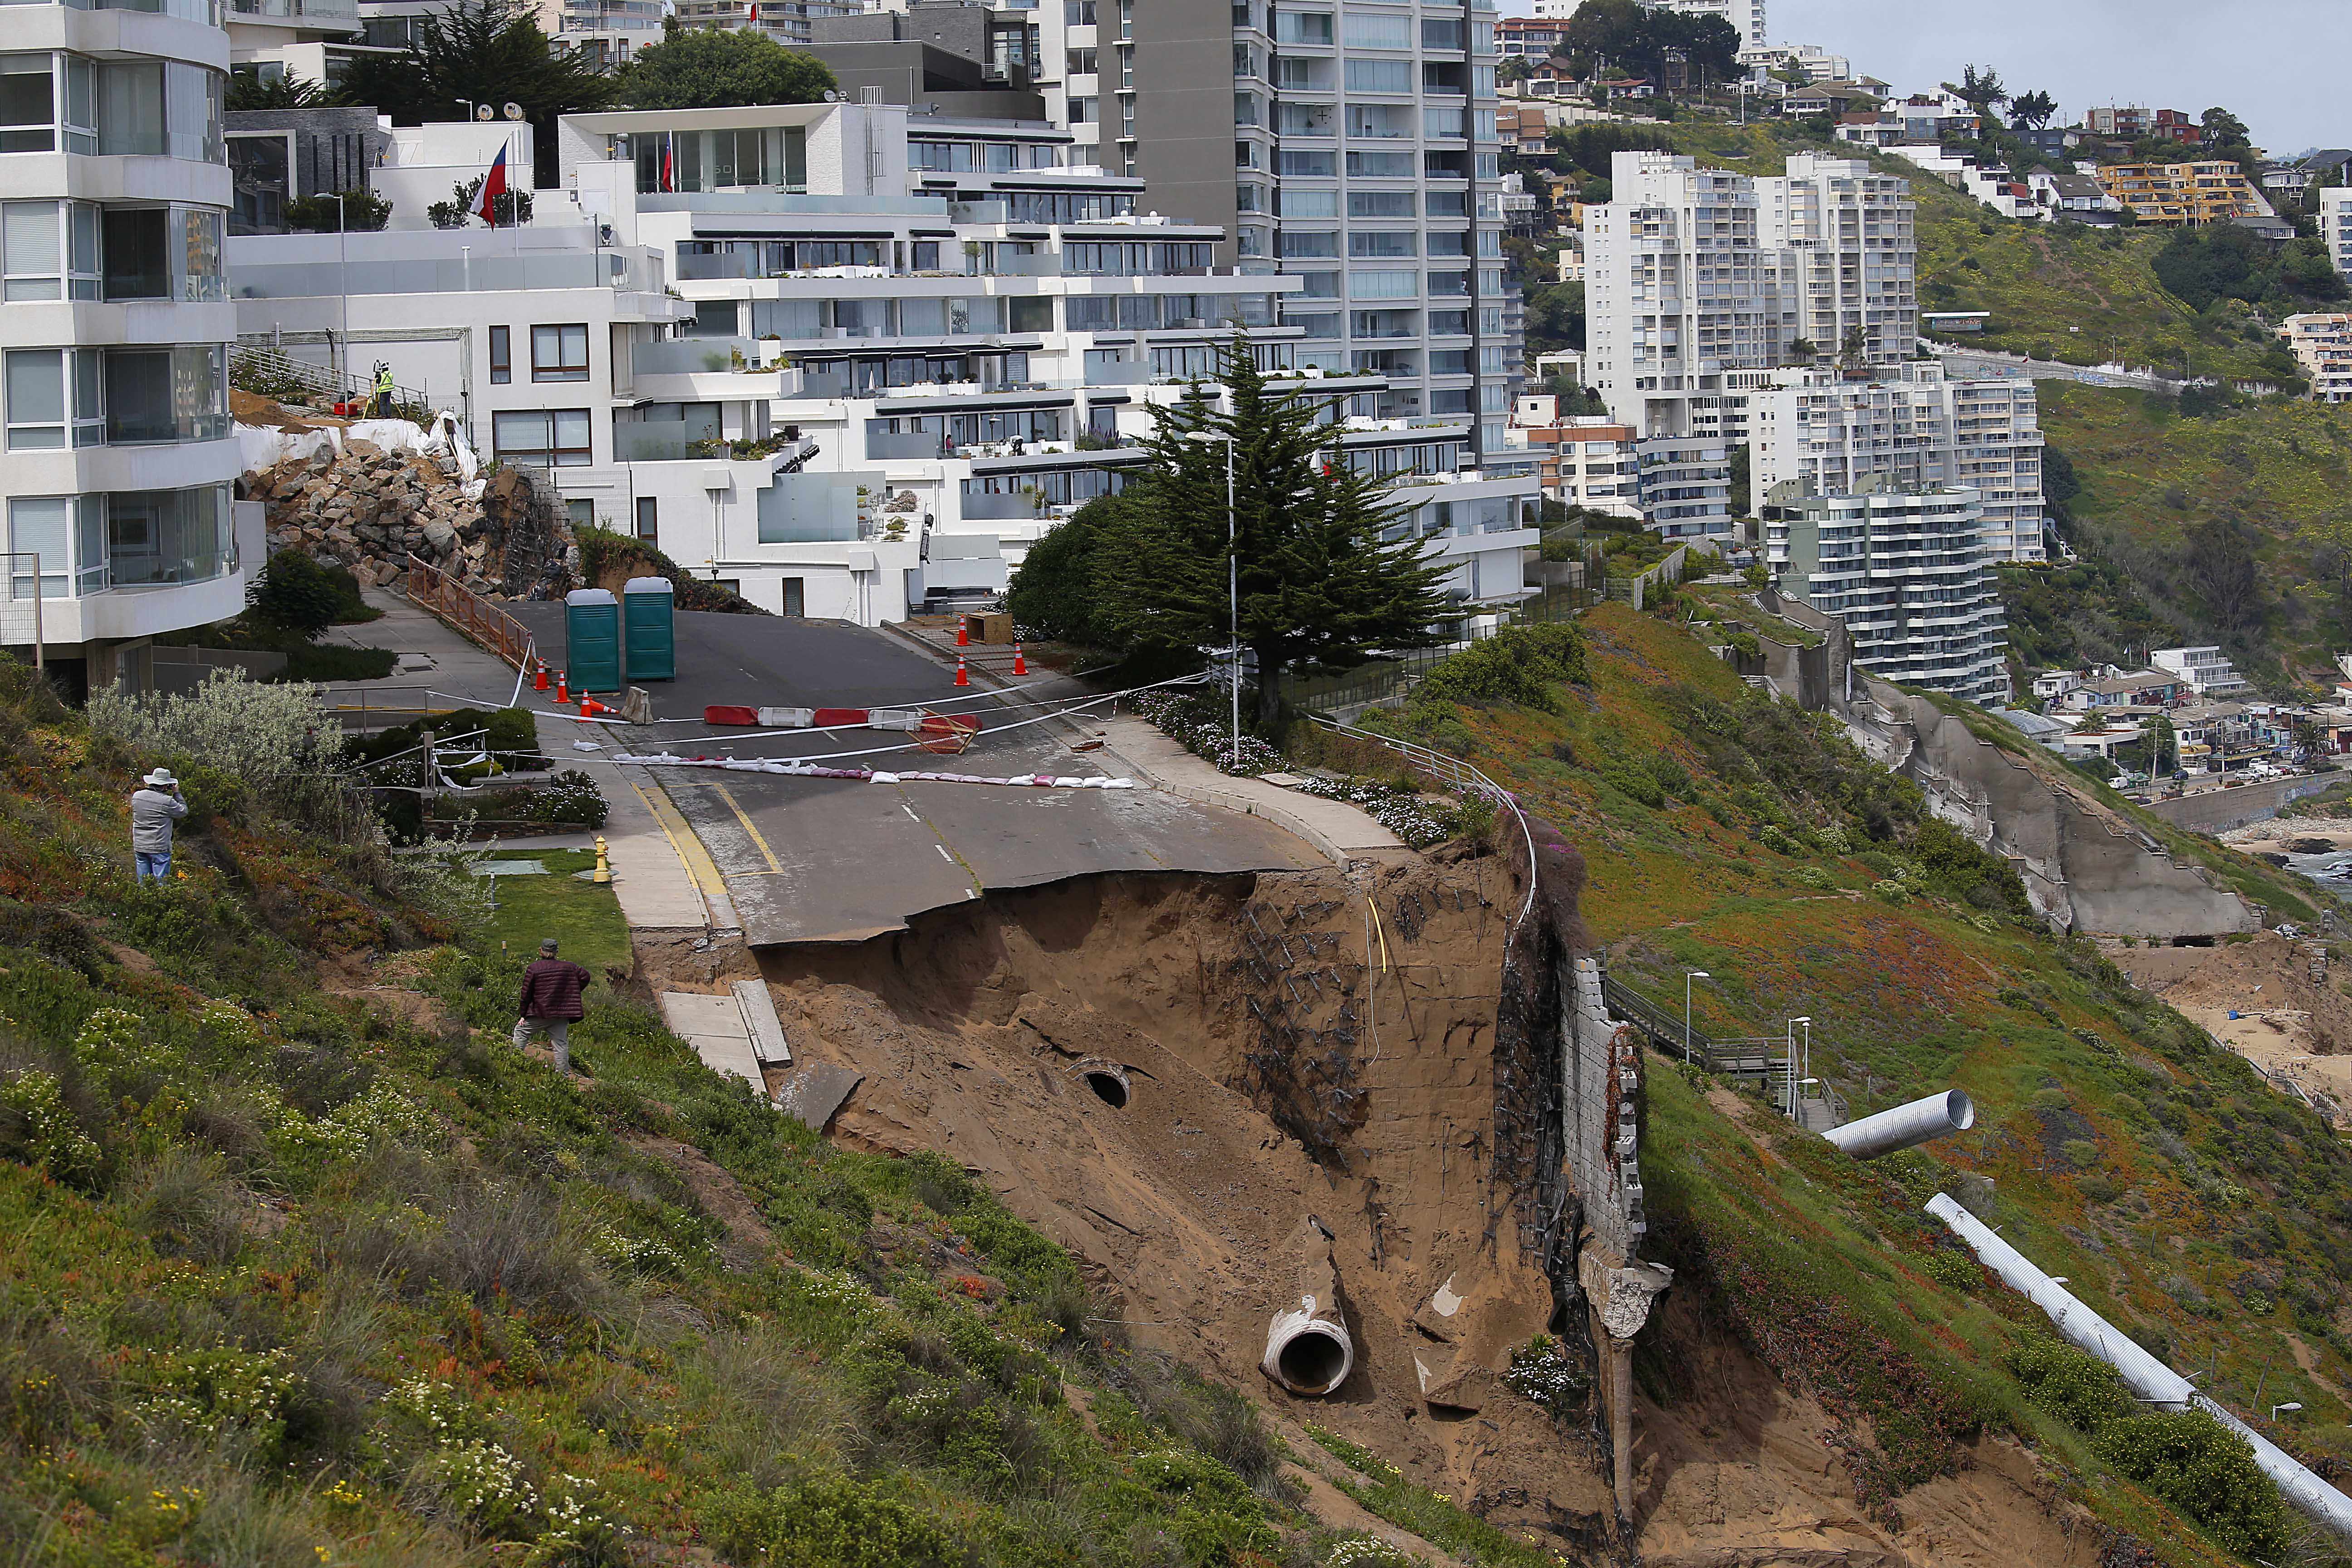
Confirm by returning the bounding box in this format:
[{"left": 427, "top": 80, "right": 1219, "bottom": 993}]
[{"left": 1383, "top": 607, "right": 2352, "bottom": 1563}]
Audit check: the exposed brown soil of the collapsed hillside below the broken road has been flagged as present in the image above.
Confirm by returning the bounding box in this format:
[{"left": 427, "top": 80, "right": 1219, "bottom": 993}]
[{"left": 757, "top": 860, "right": 2096, "bottom": 1568}]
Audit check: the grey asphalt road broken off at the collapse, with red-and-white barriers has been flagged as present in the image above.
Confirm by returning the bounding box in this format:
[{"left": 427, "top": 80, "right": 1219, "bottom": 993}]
[{"left": 508, "top": 604, "right": 1322, "bottom": 947}]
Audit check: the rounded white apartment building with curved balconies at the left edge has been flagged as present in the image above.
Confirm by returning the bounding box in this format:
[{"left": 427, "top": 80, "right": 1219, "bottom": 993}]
[{"left": 0, "top": 0, "right": 261, "bottom": 684}]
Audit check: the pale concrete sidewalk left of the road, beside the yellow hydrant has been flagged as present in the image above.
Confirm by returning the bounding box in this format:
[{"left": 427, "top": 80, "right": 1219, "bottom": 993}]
[{"left": 332, "top": 588, "right": 741, "bottom": 931}]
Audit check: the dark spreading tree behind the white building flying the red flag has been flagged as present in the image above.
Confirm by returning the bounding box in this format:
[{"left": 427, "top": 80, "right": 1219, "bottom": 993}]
[{"left": 336, "top": 0, "right": 614, "bottom": 186}]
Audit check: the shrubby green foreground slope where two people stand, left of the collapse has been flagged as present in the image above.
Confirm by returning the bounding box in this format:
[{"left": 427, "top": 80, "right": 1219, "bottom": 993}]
[{"left": 0, "top": 670, "right": 1373, "bottom": 1568}]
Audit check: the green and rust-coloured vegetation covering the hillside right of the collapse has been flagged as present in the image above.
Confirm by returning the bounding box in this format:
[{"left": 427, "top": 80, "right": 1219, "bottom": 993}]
[{"left": 1399, "top": 606, "right": 2352, "bottom": 1563}]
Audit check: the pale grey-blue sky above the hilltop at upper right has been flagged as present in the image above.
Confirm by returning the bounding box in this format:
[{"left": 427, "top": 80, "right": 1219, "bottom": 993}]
[{"left": 1500, "top": 0, "right": 2352, "bottom": 155}]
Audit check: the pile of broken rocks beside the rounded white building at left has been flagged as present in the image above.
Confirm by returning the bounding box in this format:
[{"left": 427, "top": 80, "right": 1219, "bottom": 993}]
[{"left": 240, "top": 440, "right": 578, "bottom": 599}]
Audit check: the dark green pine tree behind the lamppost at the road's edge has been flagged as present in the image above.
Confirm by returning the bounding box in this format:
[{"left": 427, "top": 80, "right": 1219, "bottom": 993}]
[{"left": 1096, "top": 336, "right": 1446, "bottom": 724}]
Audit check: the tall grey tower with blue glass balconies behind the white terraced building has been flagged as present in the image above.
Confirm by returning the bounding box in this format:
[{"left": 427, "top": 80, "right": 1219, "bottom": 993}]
[{"left": 903, "top": 0, "right": 1524, "bottom": 466}]
